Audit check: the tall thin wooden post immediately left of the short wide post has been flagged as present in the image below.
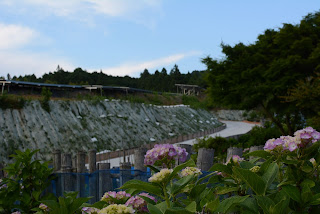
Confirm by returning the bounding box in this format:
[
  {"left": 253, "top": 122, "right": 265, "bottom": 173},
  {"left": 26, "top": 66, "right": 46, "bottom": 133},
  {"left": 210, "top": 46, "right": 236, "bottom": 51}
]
[{"left": 88, "top": 149, "right": 98, "bottom": 204}]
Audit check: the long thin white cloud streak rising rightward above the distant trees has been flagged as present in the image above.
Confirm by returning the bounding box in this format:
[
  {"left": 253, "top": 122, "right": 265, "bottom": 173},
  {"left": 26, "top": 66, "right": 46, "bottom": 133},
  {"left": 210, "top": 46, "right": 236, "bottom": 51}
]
[{"left": 89, "top": 51, "right": 201, "bottom": 76}]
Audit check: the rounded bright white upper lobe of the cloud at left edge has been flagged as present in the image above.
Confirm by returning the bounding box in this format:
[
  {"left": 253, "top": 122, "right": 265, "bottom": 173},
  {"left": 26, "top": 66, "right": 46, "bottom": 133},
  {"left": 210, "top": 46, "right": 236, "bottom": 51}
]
[{"left": 0, "top": 23, "right": 37, "bottom": 50}]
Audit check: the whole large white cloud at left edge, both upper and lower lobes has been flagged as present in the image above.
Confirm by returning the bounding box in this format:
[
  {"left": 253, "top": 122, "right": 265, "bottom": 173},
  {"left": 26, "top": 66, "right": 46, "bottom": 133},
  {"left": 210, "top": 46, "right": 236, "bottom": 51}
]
[{"left": 0, "top": 23, "right": 74, "bottom": 76}]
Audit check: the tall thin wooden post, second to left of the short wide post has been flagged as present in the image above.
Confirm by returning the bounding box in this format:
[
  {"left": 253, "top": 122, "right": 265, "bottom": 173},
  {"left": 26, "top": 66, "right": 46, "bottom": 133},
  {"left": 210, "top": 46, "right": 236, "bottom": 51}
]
[{"left": 77, "top": 151, "right": 86, "bottom": 197}]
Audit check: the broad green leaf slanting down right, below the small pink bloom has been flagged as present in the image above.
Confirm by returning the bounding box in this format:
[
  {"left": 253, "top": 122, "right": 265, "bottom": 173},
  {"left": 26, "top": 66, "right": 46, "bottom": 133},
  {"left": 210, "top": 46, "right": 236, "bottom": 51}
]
[{"left": 233, "top": 167, "right": 266, "bottom": 195}]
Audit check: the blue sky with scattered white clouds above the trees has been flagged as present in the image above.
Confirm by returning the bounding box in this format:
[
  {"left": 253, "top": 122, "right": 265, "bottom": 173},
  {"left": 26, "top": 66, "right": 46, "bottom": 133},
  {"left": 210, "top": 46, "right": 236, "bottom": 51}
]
[{"left": 0, "top": 0, "right": 320, "bottom": 77}]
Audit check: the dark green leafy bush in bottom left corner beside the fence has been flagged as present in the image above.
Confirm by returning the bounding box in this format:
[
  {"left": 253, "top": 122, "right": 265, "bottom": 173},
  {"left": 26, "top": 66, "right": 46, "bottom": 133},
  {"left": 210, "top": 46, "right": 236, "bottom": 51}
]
[{"left": 0, "top": 149, "right": 53, "bottom": 213}]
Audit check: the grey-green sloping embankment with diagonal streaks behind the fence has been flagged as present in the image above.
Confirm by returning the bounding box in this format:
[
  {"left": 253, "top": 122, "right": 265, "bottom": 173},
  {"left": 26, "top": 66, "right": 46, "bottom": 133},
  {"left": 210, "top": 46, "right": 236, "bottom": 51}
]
[{"left": 0, "top": 99, "right": 221, "bottom": 162}]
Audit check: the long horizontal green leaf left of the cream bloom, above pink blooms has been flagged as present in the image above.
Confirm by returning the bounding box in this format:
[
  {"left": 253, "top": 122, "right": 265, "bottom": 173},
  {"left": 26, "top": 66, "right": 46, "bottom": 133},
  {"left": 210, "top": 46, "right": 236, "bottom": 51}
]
[{"left": 119, "top": 180, "right": 162, "bottom": 196}]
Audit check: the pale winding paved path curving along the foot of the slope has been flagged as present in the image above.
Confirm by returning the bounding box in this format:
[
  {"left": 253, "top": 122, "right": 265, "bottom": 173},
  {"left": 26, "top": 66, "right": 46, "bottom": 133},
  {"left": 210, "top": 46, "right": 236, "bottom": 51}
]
[{"left": 101, "top": 120, "right": 257, "bottom": 168}]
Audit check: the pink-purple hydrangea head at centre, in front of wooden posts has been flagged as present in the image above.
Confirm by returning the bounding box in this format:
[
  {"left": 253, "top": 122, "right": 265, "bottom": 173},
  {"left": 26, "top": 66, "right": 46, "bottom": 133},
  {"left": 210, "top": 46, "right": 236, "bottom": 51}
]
[{"left": 144, "top": 144, "right": 188, "bottom": 167}]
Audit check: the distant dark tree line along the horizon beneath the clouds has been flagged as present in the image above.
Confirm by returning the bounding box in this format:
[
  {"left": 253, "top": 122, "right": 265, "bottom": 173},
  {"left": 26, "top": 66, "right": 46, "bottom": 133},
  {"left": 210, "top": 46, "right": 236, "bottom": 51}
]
[{"left": 8, "top": 65, "right": 206, "bottom": 92}]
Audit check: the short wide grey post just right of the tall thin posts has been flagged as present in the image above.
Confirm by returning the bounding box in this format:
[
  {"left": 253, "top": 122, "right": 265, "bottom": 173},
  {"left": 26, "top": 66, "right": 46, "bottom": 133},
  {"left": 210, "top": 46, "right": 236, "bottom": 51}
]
[{"left": 98, "top": 163, "right": 112, "bottom": 198}]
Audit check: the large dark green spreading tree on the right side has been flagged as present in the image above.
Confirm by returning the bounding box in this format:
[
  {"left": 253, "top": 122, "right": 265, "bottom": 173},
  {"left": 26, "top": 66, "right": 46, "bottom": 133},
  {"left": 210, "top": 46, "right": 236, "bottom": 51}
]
[{"left": 202, "top": 13, "right": 320, "bottom": 134}]
